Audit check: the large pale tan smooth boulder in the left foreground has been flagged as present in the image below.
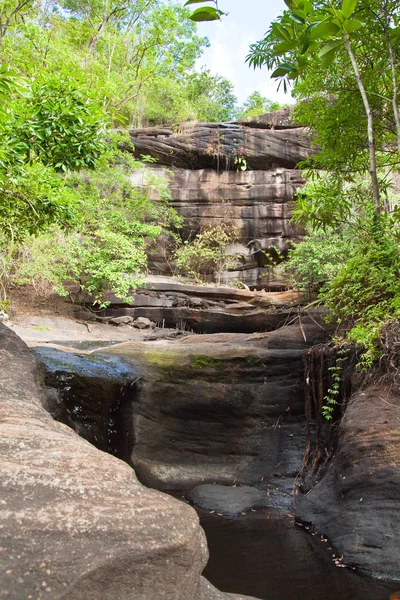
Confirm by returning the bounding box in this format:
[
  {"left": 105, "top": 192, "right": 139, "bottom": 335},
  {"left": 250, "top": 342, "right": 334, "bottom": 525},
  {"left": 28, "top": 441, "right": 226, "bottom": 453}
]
[{"left": 0, "top": 325, "right": 258, "bottom": 600}]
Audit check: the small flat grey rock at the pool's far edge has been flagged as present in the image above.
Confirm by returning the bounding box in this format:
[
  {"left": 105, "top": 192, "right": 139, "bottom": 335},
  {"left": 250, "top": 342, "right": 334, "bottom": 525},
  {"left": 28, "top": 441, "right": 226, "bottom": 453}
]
[{"left": 186, "top": 484, "right": 266, "bottom": 516}]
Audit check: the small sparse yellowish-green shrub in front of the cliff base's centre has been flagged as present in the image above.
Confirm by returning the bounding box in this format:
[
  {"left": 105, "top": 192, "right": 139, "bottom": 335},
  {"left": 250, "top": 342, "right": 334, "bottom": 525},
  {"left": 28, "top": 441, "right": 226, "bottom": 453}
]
[{"left": 175, "top": 225, "right": 235, "bottom": 283}]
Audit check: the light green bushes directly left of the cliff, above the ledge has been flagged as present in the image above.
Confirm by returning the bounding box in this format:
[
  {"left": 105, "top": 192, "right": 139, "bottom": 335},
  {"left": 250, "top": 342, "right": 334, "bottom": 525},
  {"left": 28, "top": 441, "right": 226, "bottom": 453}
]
[{"left": 13, "top": 149, "right": 181, "bottom": 305}]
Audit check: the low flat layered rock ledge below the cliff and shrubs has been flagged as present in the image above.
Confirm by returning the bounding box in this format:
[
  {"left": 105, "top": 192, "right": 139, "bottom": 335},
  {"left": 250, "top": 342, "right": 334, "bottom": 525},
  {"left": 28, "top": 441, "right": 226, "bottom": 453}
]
[{"left": 81, "top": 276, "right": 303, "bottom": 333}]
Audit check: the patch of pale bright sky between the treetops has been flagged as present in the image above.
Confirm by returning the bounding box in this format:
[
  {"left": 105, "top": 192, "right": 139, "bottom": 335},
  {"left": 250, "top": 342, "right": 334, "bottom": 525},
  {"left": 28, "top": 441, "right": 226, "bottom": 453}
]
[{"left": 193, "top": 0, "right": 291, "bottom": 103}]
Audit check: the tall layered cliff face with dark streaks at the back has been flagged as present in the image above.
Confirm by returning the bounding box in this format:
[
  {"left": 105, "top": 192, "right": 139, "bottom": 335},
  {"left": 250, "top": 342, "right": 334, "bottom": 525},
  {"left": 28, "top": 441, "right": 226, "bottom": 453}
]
[{"left": 130, "top": 110, "right": 311, "bottom": 289}]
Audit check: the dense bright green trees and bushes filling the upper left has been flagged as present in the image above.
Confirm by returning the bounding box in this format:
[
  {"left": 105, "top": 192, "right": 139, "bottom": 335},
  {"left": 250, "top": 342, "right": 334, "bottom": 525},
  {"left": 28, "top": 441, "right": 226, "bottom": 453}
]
[{"left": 0, "top": 0, "right": 278, "bottom": 308}]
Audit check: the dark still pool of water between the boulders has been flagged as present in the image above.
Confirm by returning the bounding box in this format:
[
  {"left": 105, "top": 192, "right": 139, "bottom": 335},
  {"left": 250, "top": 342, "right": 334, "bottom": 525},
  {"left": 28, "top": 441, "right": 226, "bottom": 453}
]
[{"left": 198, "top": 510, "right": 400, "bottom": 600}]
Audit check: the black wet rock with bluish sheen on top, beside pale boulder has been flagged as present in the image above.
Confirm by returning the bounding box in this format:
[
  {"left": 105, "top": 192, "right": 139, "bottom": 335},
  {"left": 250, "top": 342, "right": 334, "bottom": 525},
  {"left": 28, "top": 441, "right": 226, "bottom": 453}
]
[{"left": 34, "top": 347, "right": 138, "bottom": 461}]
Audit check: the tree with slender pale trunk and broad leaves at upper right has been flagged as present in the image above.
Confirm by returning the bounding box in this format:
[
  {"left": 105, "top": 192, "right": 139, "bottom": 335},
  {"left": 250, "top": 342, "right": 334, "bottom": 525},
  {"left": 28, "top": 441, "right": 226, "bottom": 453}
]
[{"left": 248, "top": 0, "right": 400, "bottom": 212}]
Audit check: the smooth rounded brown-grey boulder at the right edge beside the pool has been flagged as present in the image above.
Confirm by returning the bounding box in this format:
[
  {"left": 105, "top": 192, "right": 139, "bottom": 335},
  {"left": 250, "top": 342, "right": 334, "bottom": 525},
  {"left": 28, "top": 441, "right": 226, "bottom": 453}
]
[{"left": 296, "top": 385, "right": 400, "bottom": 579}]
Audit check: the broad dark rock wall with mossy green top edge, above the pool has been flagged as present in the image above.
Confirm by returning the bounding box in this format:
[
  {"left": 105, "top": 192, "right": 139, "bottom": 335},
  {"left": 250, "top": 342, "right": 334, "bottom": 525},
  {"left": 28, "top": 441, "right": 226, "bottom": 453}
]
[{"left": 97, "top": 324, "right": 328, "bottom": 494}]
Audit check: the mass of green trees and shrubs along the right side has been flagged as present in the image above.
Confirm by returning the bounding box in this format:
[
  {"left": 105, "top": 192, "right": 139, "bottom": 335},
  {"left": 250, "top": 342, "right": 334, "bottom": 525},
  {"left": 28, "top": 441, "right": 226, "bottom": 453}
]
[{"left": 187, "top": 0, "right": 400, "bottom": 367}]
